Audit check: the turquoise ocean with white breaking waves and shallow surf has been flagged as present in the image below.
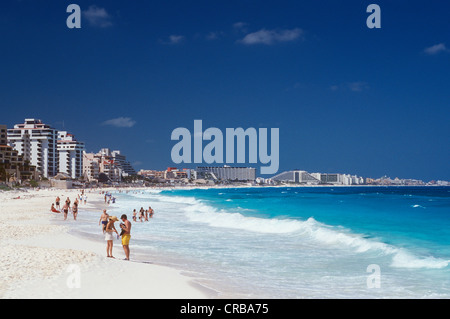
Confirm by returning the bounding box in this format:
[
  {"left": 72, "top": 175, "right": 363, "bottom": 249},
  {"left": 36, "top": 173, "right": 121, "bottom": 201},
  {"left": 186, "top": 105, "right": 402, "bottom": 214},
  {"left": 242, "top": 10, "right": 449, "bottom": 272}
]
[{"left": 71, "top": 187, "right": 450, "bottom": 299}]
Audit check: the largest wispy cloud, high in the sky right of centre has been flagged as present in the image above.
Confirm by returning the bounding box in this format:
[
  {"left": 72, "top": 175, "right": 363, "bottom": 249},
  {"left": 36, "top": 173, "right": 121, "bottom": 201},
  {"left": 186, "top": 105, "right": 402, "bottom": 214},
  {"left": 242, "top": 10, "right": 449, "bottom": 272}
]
[{"left": 239, "top": 28, "right": 304, "bottom": 45}]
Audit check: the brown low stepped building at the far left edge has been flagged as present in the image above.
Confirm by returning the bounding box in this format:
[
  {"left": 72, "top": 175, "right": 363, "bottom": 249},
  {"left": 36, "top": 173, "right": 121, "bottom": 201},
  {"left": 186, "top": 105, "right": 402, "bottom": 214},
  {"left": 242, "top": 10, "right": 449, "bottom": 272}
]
[{"left": 0, "top": 125, "right": 39, "bottom": 182}]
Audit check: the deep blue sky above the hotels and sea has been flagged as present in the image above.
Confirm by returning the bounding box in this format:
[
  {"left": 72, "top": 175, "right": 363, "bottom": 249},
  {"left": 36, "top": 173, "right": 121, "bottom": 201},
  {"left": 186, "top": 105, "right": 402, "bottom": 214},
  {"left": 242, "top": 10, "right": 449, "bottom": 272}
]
[{"left": 0, "top": 0, "right": 450, "bottom": 180}]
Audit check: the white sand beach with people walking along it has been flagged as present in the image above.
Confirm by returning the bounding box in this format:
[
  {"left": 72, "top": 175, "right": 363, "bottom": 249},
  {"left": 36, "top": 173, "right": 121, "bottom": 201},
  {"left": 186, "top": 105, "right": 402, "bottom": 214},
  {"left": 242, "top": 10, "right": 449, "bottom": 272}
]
[{"left": 0, "top": 190, "right": 214, "bottom": 299}]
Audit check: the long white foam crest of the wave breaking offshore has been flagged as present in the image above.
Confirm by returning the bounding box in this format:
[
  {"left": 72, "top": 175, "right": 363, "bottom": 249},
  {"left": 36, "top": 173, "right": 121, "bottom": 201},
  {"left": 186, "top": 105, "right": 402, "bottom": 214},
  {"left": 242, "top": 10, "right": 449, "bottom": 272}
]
[{"left": 180, "top": 197, "right": 450, "bottom": 269}]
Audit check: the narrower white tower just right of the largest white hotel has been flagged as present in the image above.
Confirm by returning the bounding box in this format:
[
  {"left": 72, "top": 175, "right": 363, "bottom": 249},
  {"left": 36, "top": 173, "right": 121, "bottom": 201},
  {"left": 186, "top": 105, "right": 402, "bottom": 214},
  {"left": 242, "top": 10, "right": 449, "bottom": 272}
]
[{"left": 57, "top": 131, "right": 85, "bottom": 179}]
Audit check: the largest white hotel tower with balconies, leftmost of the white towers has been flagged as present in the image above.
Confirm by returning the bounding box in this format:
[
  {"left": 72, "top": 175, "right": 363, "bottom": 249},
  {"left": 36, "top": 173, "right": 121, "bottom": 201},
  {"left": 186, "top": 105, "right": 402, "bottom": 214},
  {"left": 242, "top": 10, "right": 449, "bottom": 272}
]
[{"left": 8, "top": 119, "right": 59, "bottom": 178}]
